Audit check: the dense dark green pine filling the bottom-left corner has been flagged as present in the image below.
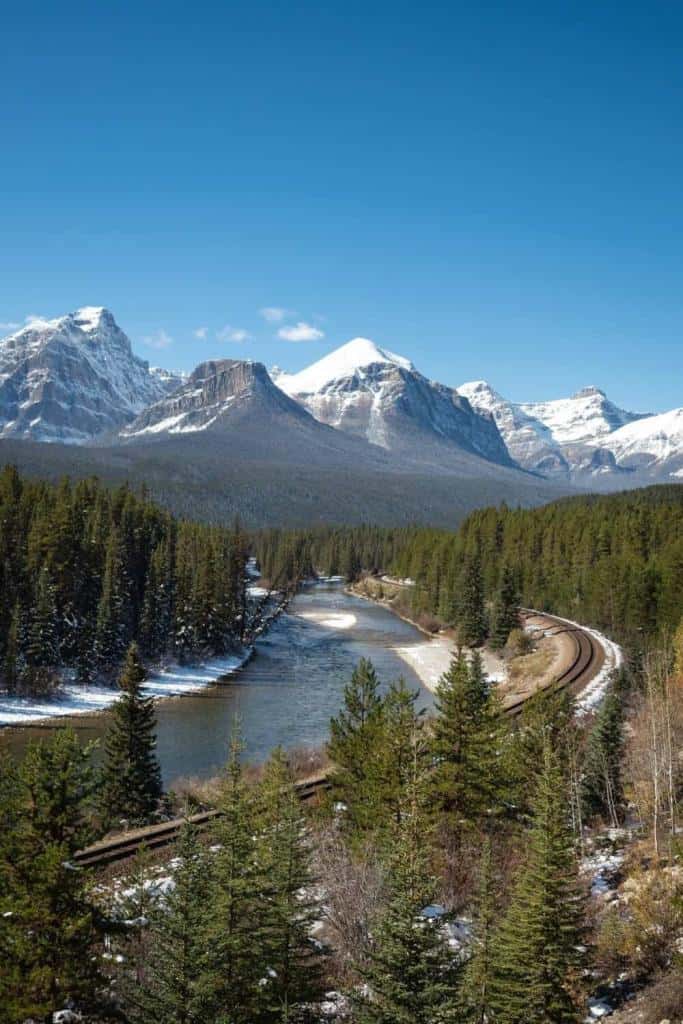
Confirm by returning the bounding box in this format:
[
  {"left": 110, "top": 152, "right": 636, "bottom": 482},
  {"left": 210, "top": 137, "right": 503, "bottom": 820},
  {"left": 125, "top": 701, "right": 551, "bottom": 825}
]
[{"left": 0, "top": 729, "right": 102, "bottom": 1021}]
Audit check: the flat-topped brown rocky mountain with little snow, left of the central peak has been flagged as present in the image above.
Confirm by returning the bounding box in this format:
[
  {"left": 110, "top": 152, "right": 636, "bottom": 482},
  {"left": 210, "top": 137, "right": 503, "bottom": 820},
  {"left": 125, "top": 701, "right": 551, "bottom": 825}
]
[{"left": 121, "top": 359, "right": 307, "bottom": 439}]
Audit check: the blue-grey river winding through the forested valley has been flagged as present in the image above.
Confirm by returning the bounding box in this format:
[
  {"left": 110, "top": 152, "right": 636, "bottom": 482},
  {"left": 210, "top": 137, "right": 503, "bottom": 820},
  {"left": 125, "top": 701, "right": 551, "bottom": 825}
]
[{"left": 0, "top": 584, "right": 432, "bottom": 786}]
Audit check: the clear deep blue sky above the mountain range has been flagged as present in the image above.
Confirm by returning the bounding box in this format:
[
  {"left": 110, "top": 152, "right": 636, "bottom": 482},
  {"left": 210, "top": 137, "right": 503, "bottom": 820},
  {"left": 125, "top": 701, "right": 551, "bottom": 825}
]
[{"left": 0, "top": 0, "right": 683, "bottom": 411}]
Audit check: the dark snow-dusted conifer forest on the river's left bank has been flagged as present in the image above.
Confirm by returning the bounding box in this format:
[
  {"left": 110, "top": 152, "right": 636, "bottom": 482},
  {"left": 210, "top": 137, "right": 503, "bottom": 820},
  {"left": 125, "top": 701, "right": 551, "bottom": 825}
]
[{"left": 0, "top": 467, "right": 246, "bottom": 692}]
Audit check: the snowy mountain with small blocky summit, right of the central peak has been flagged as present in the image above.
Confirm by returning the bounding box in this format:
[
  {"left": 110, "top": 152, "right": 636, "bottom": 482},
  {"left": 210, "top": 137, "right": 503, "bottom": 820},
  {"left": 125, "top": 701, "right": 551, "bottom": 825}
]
[{"left": 458, "top": 381, "right": 647, "bottom": 476}]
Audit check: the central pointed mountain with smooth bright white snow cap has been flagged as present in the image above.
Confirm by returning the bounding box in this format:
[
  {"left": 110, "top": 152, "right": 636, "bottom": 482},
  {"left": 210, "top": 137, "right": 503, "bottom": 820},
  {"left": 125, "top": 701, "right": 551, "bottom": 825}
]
[{"left": 273, "top": 338, "right": 512, "bottom": 466}]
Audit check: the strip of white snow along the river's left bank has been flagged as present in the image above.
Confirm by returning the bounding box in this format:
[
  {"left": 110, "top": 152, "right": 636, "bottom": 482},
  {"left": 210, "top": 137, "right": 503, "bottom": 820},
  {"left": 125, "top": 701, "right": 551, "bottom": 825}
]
[{"left": 0, "top": 648, "right": 252, "bottom": 725}]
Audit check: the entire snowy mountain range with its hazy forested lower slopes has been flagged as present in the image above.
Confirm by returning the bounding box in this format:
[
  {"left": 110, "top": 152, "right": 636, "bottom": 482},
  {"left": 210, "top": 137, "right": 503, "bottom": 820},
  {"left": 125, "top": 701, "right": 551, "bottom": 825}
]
[{"left": 0, "top": 306, "right": 683, "bottom": 524}]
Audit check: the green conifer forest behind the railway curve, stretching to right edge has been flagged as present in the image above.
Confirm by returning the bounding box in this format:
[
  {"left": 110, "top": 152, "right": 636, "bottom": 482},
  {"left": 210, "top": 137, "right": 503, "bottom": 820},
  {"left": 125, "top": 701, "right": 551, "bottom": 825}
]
[{"left": 257, "top": 485, "right": 683, "bottom": 643}]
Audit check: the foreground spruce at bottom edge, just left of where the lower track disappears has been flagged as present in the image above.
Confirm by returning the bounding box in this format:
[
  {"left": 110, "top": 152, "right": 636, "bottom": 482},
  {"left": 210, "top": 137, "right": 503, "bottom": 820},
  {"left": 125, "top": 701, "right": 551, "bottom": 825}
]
[{"left": 254, "top": 748, "right": 322, "bottom": 1024}]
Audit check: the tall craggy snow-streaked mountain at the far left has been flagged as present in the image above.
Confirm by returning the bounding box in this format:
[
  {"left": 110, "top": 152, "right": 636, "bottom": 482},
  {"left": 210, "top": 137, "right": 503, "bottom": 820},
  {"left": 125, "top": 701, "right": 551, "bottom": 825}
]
[{"left": 0, "top": 306, "right": 180, "bottom": 444}]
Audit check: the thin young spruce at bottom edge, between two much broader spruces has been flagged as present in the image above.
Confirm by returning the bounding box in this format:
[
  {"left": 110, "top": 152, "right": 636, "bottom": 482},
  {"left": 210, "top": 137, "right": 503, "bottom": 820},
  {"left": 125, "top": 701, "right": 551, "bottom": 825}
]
[{"left": 458, "top": 837, "right": 499, "bottom": 1024}]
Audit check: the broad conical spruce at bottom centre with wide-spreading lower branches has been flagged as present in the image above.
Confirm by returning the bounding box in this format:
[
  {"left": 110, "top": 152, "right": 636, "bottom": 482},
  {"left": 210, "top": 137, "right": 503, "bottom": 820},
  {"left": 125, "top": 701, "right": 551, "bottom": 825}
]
[{"left": 352, "top": 730, "right": 460, "bottom": 1024}]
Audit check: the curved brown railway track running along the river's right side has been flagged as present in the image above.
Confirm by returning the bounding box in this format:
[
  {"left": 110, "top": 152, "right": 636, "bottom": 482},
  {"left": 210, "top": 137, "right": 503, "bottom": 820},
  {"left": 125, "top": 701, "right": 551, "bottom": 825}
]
[{"left": 73, "top": 608, "right": 604, "bottom": 867}]
